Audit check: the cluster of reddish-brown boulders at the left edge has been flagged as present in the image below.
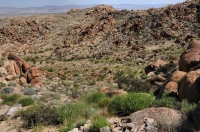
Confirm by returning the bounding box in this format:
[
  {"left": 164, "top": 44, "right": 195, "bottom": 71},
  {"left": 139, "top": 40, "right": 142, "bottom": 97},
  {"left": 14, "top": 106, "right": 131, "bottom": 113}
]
[{"left": 0, "top": 53, "right": 42, "bottom": 87}]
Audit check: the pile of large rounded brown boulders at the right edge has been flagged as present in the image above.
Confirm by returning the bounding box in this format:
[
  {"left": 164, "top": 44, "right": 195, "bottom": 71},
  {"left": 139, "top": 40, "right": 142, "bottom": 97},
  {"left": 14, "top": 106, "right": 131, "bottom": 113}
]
[{"left": 149, "top": 41, "right": 200, "bottom": 102}]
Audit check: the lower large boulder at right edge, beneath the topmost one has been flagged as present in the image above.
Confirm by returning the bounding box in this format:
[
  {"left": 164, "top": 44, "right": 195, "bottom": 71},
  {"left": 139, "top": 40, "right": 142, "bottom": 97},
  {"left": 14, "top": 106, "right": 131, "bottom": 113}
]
[{"left": 178, "top": 69, "right": 200, "bottom": 102}]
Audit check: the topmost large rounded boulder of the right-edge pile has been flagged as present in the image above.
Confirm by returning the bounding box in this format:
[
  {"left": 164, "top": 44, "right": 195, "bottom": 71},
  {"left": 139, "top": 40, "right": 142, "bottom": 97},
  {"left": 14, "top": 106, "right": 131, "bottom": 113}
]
[{"left": 179, "top": 41, "right": 200, "bottom": 72}]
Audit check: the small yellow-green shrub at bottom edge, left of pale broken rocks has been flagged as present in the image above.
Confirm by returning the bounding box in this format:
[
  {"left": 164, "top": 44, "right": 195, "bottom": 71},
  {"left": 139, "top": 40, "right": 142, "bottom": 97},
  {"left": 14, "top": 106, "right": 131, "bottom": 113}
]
[{"left": 90, "top": 115, "right": 110, "bottom": 132}]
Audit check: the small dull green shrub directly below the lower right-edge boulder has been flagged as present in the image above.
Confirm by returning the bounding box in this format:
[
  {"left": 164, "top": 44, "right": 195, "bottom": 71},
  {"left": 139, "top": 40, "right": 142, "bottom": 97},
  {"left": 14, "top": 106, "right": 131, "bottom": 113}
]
[{"left": 181, "top": 99, "right": 197, "bottom": 115}]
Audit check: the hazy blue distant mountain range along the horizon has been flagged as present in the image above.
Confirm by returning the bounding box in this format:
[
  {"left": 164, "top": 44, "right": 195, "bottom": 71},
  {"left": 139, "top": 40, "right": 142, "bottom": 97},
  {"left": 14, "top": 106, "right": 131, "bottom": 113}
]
[{"left": 0, "top": 4, "right": 166, "bottom": 17}]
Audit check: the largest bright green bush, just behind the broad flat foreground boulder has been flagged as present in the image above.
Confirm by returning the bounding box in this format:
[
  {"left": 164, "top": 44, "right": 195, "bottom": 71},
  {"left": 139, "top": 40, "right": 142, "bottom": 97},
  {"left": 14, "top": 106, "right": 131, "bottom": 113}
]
[{"left": 108, "top": 93, "right": 154, "bottom": 115}]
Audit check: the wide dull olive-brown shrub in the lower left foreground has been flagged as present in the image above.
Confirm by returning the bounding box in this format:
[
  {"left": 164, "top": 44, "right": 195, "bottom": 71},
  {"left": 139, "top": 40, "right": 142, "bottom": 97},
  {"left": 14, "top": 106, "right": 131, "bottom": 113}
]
[{"left": 16, "top": 104, "right": 62, "bottom": 128}]
